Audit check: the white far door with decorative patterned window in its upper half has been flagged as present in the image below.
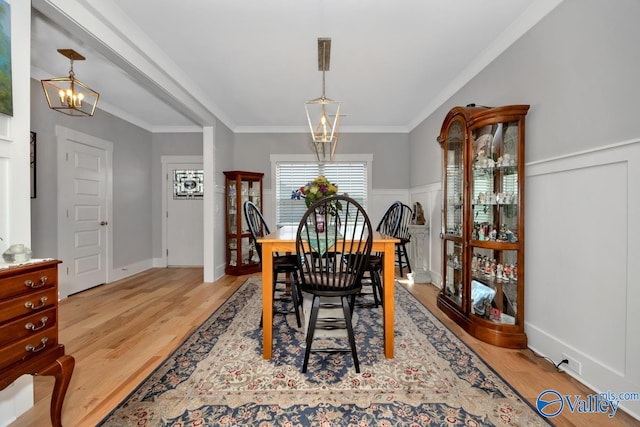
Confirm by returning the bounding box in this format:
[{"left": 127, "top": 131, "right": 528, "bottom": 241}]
[{"left": 166, "top": 163, "right": 204, "bottom": 266}]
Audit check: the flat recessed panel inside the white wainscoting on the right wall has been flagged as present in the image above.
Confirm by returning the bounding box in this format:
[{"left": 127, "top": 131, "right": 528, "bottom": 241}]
[{"left": 525, "top": 162, "right": 628, "bottom": 372}]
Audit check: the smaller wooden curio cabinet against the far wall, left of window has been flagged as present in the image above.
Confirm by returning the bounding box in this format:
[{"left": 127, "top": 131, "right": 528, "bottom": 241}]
[{"left": 224, "top": 171, "right": 264, "bottom": 276}]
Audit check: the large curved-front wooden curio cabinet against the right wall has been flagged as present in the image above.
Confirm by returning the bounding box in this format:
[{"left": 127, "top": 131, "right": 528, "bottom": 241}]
[{"left": 438, "top": 104, "right": 529, "bottom": 348}]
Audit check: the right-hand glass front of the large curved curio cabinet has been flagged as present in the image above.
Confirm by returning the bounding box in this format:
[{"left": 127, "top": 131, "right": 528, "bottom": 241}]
[{"left": 470, "top": 121, "right": 520, "bottom": 325}]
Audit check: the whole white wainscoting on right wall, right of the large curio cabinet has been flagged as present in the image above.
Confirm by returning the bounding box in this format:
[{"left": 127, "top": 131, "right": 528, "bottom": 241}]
[{"left": 525, "top": 140, "right": 640, "bottom": 417}]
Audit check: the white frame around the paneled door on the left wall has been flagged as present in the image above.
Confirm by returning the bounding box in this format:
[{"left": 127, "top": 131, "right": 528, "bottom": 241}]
[{"left": 55, "top": 125, "right": 113, "bottom": 298}]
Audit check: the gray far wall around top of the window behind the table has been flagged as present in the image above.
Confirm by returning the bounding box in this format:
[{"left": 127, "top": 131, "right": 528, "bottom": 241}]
[{"left": 233, "top": 133, "right": 409, "bottom": 190}]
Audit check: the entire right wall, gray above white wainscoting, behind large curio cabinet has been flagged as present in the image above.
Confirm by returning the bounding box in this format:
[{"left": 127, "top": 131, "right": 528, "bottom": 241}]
[{"left": 409, "top": 0, "right": 640, "bottom": 417}]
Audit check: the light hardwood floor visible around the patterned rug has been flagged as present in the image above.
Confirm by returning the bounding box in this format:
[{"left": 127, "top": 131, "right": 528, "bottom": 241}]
[{"left": 10, "top": 268, "right": 640, "bottom": 427}]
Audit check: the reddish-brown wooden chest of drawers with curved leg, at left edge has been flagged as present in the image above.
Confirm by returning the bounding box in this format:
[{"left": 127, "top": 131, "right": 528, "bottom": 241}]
[{"left": 0, "top": 260, "right": 75, "bottom": 427}]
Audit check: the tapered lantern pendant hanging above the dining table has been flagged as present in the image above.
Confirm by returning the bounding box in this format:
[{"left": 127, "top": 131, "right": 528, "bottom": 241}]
[{"left": 304, "top": 38, "right": 340, "bottom": 161}]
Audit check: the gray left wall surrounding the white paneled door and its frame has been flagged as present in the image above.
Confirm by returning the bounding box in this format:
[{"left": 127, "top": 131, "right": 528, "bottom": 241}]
[{"left": 31, "top": 76, "right": 152, "bottom": 268}]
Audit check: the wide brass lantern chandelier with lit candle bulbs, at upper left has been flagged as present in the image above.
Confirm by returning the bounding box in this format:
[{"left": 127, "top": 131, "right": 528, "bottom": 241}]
[{"left": 40, "top": 49, "right": 100, "bottom": 117}]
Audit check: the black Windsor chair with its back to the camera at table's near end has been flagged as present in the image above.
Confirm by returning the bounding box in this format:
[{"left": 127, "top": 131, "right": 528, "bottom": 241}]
[{"left": 296, "top": 195, "right": 373, "bottom": 373}]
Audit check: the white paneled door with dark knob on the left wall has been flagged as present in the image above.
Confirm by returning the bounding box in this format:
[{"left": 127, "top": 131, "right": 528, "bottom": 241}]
[{"left": 58, "top": 132, "right": 112, "bottom": 296}]
